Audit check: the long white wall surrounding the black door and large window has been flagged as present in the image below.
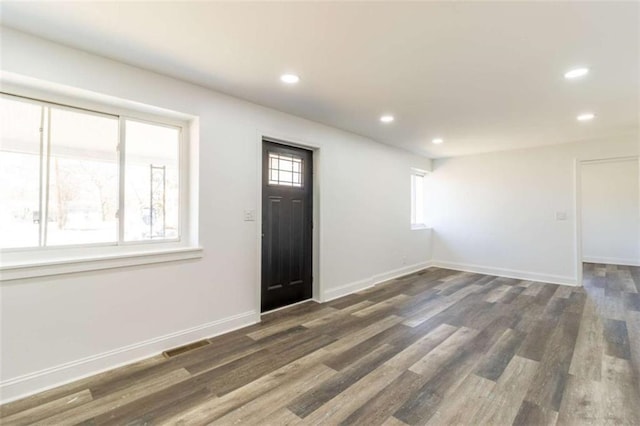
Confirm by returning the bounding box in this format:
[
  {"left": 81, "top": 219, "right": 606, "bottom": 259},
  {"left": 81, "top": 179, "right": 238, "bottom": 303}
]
[{"left": 0, "top": 29, "right": 431, "bottom": 401}]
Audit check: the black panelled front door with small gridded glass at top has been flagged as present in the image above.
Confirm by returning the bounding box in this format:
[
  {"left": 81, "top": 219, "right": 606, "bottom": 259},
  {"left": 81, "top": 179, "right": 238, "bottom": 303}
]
[{"left": 262, "top": 141, "right": 313, "bottom": 312}]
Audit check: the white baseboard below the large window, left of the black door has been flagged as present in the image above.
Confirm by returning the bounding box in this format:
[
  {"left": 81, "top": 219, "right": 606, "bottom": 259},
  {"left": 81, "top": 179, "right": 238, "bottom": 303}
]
[{"left": 0, "top": 311, "right": 260, "bottom": 404}]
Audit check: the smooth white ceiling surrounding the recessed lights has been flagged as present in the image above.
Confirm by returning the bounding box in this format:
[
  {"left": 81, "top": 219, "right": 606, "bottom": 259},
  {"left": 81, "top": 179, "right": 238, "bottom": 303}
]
[{"left": 1, "top": 1, "right": 640, "bottom": 157}]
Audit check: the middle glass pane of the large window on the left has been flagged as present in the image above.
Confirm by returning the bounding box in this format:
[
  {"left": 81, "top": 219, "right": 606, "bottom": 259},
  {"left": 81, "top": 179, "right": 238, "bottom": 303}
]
[{"left": 44, "top": 108, "right": 119, "bottom": 245}]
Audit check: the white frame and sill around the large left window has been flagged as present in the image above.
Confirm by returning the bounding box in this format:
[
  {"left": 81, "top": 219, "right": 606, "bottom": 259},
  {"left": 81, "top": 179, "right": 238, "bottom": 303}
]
[{"left": 0, "top": 88, "right": 202, "bottom": 281}]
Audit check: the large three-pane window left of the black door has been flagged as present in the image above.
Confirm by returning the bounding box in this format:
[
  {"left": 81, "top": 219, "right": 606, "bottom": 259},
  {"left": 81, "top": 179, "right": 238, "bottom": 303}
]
[{"left": 0, "top": 95, "right": 182, "bottom": 249}]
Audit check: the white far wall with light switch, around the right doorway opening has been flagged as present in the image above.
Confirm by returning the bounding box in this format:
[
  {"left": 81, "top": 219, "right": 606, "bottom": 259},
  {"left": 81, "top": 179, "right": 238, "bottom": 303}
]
[{"left": 432, "top": 135, "right": 638, "bottom": 285}]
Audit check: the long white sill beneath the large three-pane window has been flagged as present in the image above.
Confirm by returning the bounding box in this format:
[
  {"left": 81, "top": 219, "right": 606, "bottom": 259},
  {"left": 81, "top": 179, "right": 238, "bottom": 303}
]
[{"left": 0, "top": 247, "right": 203, "bottom": 281}]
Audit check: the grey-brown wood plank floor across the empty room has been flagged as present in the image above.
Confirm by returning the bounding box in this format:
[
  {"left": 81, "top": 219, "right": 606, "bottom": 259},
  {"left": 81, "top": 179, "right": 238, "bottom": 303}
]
[{"left": 0, "top": 264, "right": 640, "bottom": 425}]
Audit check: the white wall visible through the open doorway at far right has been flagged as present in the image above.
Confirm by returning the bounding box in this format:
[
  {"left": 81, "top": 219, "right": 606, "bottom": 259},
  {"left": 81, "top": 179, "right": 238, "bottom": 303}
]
[{"left": 580, "top": 158, "right": 640, "bottom": 266}]
